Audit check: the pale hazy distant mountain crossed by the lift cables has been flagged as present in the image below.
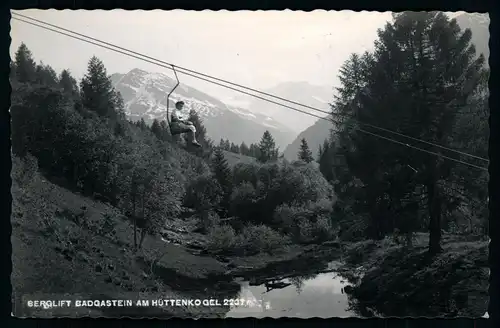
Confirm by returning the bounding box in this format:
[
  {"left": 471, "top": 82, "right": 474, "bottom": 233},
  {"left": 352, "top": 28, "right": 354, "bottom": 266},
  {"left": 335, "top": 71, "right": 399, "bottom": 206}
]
[{"left": 227, "top": 82, "right": 333, "bottom": 133}]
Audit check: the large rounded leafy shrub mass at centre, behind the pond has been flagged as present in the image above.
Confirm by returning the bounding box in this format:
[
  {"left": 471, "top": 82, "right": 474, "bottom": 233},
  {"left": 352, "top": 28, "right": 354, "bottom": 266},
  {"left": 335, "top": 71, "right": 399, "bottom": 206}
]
[{"left": 230, "top": 163, "right": 333, "bottom": 228}]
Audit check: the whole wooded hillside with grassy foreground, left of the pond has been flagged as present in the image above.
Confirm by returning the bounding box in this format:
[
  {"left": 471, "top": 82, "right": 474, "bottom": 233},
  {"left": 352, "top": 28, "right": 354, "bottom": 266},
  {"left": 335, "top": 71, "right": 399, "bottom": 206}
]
[{"left": 11, "top": 44, "right": 334, "bottom": 316}]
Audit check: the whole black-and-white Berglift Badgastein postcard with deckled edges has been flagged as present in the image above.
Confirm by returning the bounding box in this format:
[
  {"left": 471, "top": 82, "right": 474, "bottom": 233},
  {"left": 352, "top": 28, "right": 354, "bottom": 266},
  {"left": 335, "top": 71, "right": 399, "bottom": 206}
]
[{"left": 10, "top": 9, "right": 490, "bottom": 319}]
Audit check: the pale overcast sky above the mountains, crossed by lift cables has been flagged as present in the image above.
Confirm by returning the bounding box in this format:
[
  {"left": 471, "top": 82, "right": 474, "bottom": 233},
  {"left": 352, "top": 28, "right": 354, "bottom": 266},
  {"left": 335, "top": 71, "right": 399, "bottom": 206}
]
[{"left": 11, "top": 9, "right": 464, "bottom": 98}]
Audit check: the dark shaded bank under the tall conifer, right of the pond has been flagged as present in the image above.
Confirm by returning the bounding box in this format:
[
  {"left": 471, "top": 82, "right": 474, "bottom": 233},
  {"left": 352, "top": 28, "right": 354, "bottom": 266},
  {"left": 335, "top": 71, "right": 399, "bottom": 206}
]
[{"left": 341, "top": 234, "right": 489, "bottom": 317}]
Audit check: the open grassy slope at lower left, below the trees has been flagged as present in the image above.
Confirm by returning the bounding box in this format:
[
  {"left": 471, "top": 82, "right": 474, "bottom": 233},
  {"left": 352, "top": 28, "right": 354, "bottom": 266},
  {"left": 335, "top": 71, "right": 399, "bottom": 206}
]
[{"left": 11, "top": 170, "right": 234, "bottom": 316}]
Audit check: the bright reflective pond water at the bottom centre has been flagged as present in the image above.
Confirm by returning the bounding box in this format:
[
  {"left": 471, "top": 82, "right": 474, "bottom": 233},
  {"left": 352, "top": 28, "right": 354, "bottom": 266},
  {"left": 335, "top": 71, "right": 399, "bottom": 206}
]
[{"left": 226, "top": 262, "right": 356, "bottom": 318}]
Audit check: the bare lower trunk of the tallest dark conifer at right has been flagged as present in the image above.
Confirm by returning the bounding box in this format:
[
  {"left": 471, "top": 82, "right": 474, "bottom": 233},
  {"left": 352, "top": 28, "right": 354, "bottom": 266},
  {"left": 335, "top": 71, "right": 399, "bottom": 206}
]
[{"left": 427, "top": 179, "right": 441, "bottom": 256}]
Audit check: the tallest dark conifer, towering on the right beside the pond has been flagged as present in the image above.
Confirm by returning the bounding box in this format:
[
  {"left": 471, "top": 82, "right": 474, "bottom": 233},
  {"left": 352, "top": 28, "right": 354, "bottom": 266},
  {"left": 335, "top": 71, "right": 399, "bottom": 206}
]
[{"left": 334, "top": 12, "right": 484, "bottom": 254}]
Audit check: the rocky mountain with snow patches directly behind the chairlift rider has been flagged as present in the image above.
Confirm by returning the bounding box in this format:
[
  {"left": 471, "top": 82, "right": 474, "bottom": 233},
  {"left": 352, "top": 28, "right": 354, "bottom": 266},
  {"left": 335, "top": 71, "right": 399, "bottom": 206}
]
[{"left": 111, "top": 68, "right": 295, "bottom": 148}]
